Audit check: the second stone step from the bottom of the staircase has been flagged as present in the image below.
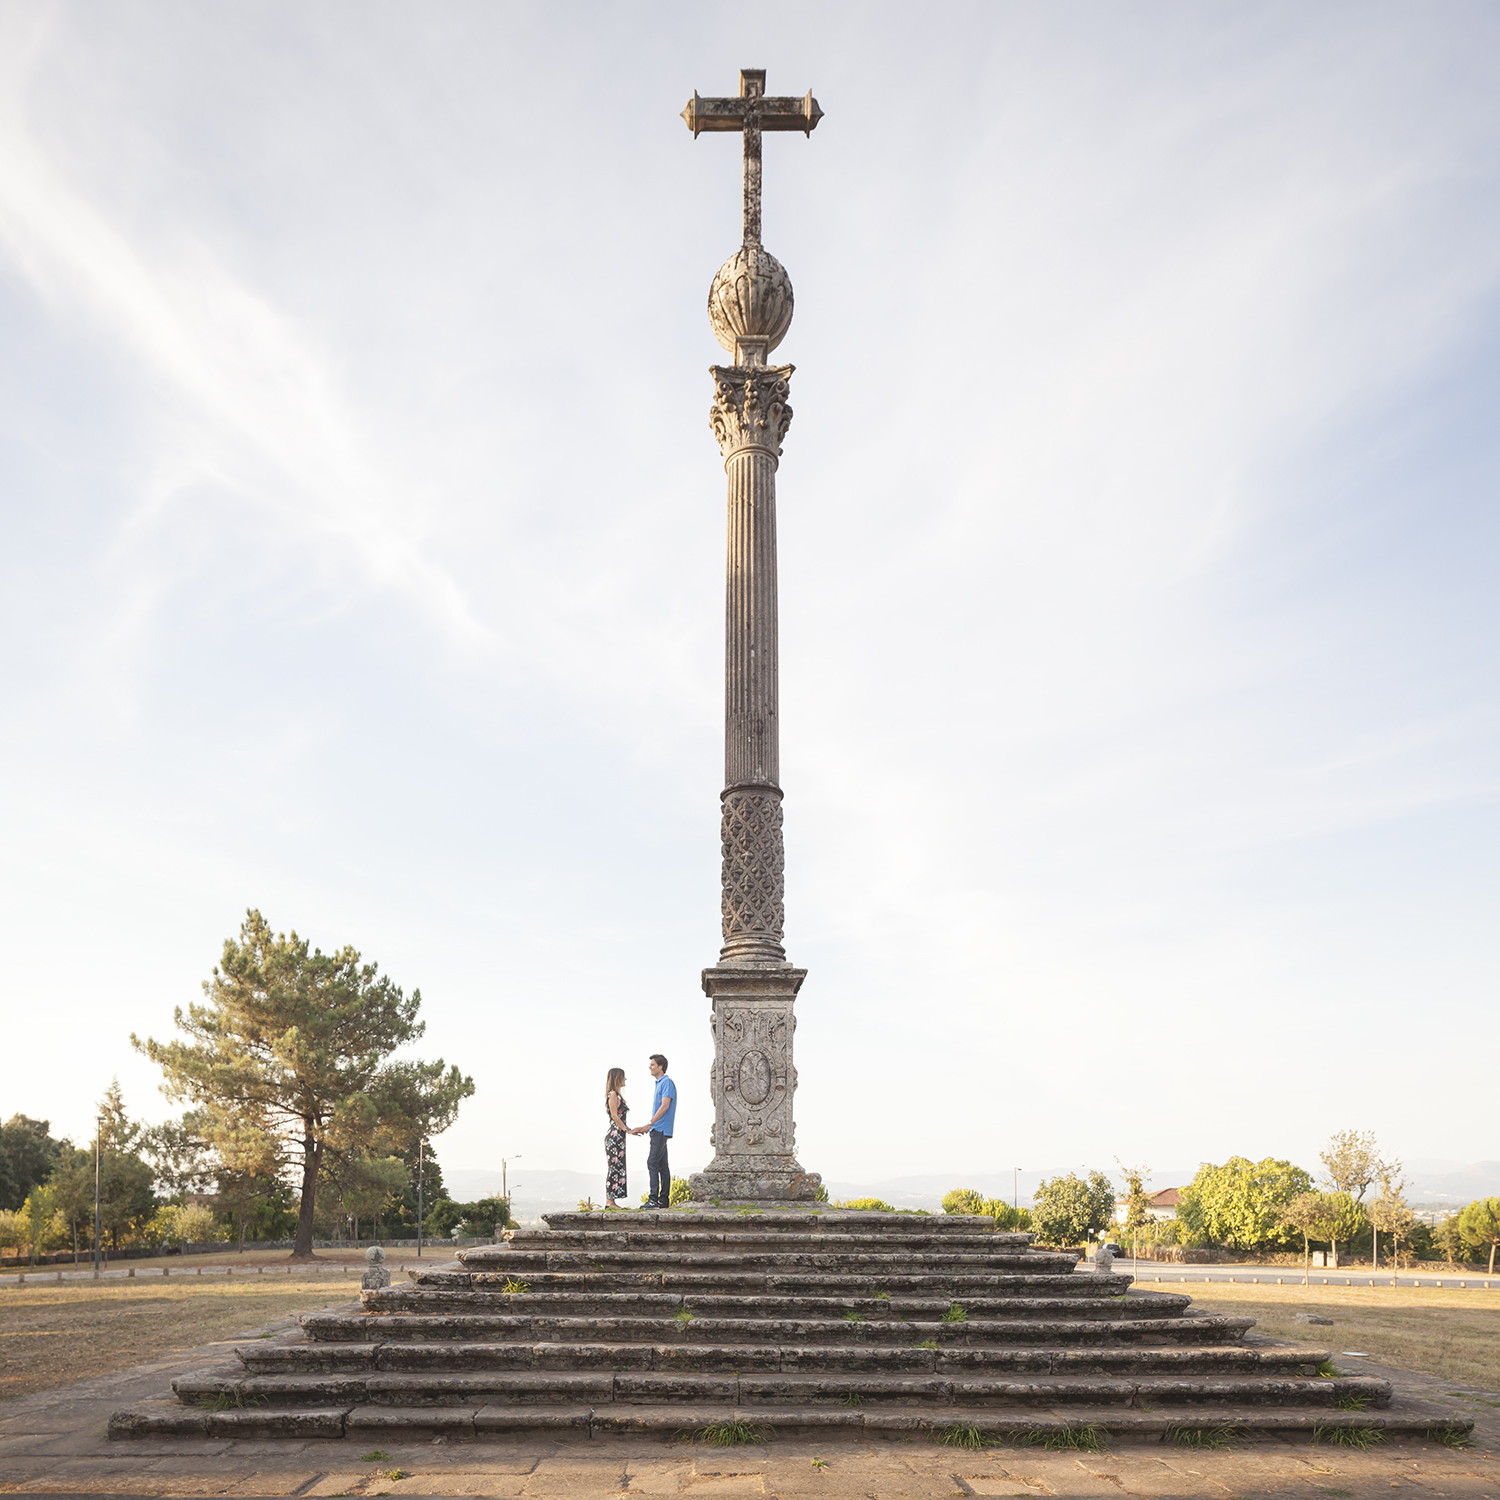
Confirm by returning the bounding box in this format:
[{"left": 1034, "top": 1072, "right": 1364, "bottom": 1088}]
[{"left": 173, "top": 1368, "right": 1391, "bottom": 1410}]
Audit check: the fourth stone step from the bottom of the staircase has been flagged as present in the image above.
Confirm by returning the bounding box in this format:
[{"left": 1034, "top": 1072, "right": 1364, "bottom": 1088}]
[{"left": 300, "top": 1298, "right": 1254, "bottom": 1347}]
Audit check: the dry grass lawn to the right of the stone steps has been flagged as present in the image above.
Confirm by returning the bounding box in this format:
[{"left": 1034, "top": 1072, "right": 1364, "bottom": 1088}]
[{"left": 1142, "top": 1281, "right": 1500, "bottom": 1391}]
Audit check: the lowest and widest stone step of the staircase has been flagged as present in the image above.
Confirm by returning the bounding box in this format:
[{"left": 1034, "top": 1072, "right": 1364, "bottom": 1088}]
[{"left": 110, "top": 1400, "right": 1473, "bottom": 1445}]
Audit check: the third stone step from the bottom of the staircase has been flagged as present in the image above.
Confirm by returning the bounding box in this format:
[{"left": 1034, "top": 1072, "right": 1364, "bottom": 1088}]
[{"left": 236, "top": 1341, "right": 1328, "bottom": 1377}]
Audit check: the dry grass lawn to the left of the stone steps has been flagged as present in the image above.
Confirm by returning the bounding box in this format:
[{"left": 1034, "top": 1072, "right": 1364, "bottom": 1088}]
[{"left": 0, "top": 1274, "right": 359, "bottom": 1401}]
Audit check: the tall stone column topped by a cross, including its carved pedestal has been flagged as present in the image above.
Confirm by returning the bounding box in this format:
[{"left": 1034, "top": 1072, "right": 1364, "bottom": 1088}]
[{"left": 683, "top": 68, "right": 824, "bottom": 1203}]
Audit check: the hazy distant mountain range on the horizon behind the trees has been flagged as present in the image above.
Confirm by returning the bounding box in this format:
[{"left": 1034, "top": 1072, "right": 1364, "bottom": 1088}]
[{"left": 444, "top": 1160, "right": 1500, "bottom": 1221}]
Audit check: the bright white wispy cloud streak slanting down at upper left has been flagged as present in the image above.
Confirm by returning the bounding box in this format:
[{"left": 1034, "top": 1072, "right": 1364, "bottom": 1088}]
[{"left": 0, "top": 27, "right": 494, "bottom": 648}]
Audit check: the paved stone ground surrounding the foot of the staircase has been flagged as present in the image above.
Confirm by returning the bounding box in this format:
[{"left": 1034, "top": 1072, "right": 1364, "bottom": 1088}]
[{"left": 0, "top": 1320, "right": 1500, "bottom": 1500}]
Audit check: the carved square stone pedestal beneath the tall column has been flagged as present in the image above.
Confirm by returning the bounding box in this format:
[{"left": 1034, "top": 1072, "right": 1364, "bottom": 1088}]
[{"left": 687, "top": 963, "right": 822, "bottom": 1203}]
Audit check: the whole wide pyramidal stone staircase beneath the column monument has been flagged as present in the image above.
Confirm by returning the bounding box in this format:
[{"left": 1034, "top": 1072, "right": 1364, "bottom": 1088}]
[{"left": 110, "top": 1205, "right": 1470, "bottom": 1443}]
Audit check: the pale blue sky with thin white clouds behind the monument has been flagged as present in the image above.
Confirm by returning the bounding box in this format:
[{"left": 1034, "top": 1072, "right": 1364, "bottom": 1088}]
[{"left": 0, "top": 0, "right": 1500, "bottom": 1184}]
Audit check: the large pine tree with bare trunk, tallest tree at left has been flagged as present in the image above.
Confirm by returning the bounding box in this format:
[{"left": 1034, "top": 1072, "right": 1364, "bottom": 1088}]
[{"left": 131, "top": 911, "right": 474, "bottom": 1259}]
